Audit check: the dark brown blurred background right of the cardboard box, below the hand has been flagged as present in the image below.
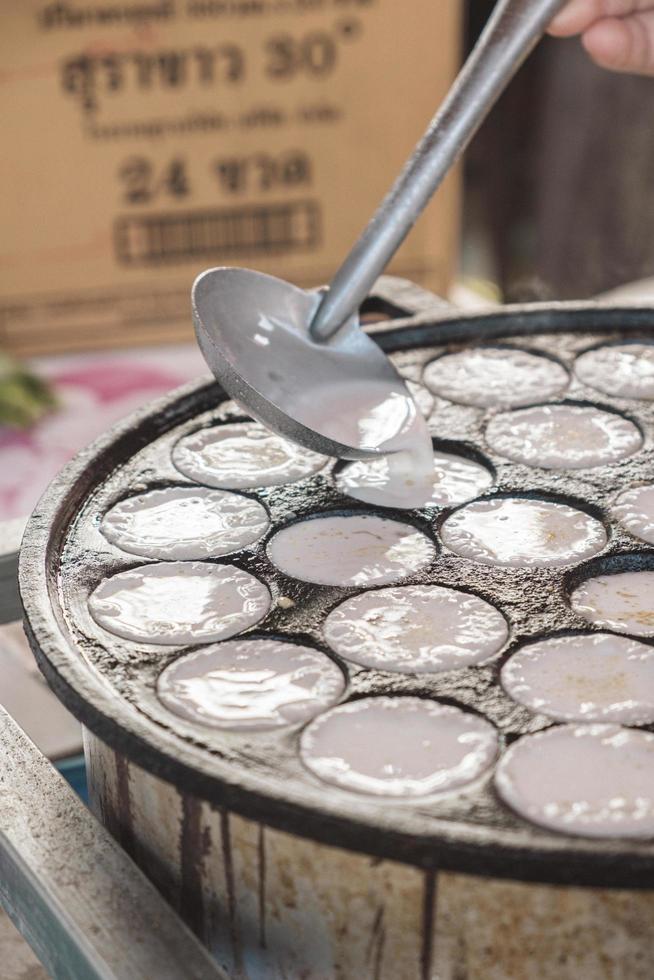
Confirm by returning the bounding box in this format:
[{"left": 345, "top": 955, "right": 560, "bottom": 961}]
[{"left": 463, "top": 0, "right": 654, "bottom": 301}]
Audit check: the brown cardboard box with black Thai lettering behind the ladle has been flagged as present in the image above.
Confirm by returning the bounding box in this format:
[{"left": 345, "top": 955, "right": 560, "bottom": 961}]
[{"left": 0, "top": 0, "right": 461, "bottom": 354}]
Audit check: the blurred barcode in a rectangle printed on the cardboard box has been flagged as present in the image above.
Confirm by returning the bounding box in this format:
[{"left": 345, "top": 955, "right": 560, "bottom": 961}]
[{"left": 114, "top": 201, "right": 321, "bottom": 266}]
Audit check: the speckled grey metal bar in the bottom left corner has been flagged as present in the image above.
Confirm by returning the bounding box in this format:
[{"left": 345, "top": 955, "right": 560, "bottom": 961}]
[{"left": 0, "top": 708, "right": 225, "bottom": 980}]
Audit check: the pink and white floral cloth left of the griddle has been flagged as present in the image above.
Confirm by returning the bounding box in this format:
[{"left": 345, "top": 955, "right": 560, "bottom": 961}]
[{"left": 0, "top": 344, "right": 208, "bottom": 520}]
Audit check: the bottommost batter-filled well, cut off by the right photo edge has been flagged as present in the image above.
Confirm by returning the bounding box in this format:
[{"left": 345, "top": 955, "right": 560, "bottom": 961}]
[{"left": 495, "top": 725, "right": 654, "bottom": 837}]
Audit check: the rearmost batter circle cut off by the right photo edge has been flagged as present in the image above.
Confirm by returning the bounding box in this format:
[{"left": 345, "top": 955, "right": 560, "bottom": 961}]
[{"left": 575, "top": 343, "right": 654, "bottom": 401}]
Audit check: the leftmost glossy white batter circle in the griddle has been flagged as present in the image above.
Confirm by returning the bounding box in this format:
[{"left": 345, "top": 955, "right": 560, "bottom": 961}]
[{"left": 89, "top": 562, "right": 271, "bottom": 646}]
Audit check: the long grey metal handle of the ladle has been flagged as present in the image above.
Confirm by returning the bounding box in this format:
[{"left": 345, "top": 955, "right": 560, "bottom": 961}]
[{"left": 310, "top": 0, "right": 566, "bottom": 340}]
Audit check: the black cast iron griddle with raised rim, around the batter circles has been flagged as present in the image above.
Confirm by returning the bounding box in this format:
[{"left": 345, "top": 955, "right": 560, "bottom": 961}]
[{"left": 15, "top": 279, "right": 654, "bottom": 888}]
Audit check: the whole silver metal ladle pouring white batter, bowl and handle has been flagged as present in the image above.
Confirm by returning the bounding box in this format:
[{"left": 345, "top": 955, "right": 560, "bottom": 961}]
[{"left": 192, "top": 0, "right": 566, "bottom": 459}]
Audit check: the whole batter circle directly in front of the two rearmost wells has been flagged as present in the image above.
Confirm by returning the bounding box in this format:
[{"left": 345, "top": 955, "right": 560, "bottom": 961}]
[{"left": 486, "top": 405, "right": 643, "bottom": 470}]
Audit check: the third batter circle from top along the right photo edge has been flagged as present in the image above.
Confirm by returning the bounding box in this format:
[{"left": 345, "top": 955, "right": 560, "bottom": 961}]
[{"left": 570, "top": 571, "right": 654, "bottom": 636}]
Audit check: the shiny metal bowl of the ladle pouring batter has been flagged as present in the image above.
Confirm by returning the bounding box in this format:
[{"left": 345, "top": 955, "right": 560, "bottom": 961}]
[{"left": 192, "top": 268, "right": 416, "bottom": 459}]
